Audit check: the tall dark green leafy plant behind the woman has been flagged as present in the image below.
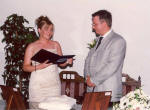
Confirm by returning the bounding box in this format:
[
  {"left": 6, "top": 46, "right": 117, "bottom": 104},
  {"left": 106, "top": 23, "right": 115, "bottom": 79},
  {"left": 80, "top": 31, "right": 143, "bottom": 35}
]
[{"left": 0, "top": 14, "right": 38, "bottom": 102}]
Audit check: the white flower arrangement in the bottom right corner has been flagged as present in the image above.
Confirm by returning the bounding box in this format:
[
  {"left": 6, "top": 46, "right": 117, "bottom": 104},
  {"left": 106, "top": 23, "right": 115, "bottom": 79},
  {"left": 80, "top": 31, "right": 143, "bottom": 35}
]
[{"left": 113, "top": 88, "right": 150, "bottom": 110}]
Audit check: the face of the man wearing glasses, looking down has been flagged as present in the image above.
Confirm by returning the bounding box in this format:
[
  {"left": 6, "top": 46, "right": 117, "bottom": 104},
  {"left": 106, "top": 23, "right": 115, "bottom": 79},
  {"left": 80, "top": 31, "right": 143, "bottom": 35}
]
[{"left": 92, "top": 16, "right": 103, "bottom": 35}]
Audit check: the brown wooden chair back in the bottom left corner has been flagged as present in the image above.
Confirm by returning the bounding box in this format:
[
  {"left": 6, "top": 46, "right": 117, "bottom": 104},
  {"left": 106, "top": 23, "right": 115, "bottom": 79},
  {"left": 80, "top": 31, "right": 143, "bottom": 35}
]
[{"left": 0, "top": 85, "right": 26, "bottom": 110}]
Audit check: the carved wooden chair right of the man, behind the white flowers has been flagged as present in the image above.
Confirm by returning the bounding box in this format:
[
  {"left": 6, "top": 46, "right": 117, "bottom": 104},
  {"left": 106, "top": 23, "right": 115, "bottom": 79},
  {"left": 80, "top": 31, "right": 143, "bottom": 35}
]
[{"left": 122, "top": 73, "right": 141, "bottom": 96}]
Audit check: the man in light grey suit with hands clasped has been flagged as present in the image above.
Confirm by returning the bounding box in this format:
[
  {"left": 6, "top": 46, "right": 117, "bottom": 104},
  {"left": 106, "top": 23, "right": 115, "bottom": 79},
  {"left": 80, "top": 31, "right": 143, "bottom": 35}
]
[{"left": 84, "top": 10, "right": 126, "bottom": 106}]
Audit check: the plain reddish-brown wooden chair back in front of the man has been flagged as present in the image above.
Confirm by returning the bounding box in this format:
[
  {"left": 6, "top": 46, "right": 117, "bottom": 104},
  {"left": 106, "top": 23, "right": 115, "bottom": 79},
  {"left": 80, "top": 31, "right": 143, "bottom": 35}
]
[{"left": 82, "top": 91, "right": 112, "bottom": 110}]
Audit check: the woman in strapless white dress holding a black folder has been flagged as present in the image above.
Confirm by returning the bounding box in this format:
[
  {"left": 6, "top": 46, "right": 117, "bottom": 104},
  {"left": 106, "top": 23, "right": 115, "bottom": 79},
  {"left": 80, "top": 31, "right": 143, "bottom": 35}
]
[{"left": 23, "top": 16, "right": 73, "bottom": 109}]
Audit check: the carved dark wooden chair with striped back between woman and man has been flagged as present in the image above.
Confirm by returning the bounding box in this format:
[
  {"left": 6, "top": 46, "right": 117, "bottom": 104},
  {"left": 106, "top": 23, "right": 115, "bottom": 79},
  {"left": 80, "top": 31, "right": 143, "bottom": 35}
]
[{"left": 60, "top": 71, "right": 86, "bottom": 104}]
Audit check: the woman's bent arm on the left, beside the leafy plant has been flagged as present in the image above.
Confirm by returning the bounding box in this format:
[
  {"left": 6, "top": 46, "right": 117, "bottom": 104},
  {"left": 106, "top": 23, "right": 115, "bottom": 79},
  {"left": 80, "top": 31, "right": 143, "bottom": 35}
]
[{"left": 23, "top": 44, "right": 50, "bottom": 72}]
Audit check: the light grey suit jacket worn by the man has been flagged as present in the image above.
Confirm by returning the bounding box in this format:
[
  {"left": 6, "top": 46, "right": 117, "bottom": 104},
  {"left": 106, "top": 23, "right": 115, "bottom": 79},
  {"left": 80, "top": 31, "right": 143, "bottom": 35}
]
[{"left": 84, "top": 31, "right": 126, "bottom": 102}]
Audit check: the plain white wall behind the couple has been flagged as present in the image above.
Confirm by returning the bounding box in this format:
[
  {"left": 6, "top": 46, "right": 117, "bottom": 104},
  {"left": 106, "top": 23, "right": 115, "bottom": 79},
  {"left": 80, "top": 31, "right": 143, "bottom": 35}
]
[{"left": 0, "top": 0, "right": 150, "bottom": 94}]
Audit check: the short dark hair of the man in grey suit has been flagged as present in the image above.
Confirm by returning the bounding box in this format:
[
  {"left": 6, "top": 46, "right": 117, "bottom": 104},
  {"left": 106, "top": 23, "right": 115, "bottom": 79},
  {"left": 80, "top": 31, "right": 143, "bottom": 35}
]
[{"left": 92, "top": 10, "right": 112, "bottom": 27}]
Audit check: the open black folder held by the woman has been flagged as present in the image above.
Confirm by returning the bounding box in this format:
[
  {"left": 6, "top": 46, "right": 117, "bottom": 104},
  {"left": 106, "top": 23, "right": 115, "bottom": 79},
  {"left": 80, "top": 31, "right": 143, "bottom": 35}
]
[{"left": 31, "top": 49, "right": 75, "bottom": 64}]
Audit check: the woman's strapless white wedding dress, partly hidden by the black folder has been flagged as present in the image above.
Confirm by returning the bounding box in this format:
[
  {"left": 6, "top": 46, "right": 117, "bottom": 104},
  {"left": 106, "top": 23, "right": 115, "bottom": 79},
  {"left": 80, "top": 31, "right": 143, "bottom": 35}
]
[{"left": 29, "top": 49, "right": 61, "bottom": 103}]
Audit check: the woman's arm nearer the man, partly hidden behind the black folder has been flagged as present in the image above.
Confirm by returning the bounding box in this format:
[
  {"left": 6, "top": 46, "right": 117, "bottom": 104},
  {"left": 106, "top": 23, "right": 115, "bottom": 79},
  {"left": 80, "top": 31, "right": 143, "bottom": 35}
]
[{"left": 55, "top": 42, "right": 73, "bottom": 67}]
